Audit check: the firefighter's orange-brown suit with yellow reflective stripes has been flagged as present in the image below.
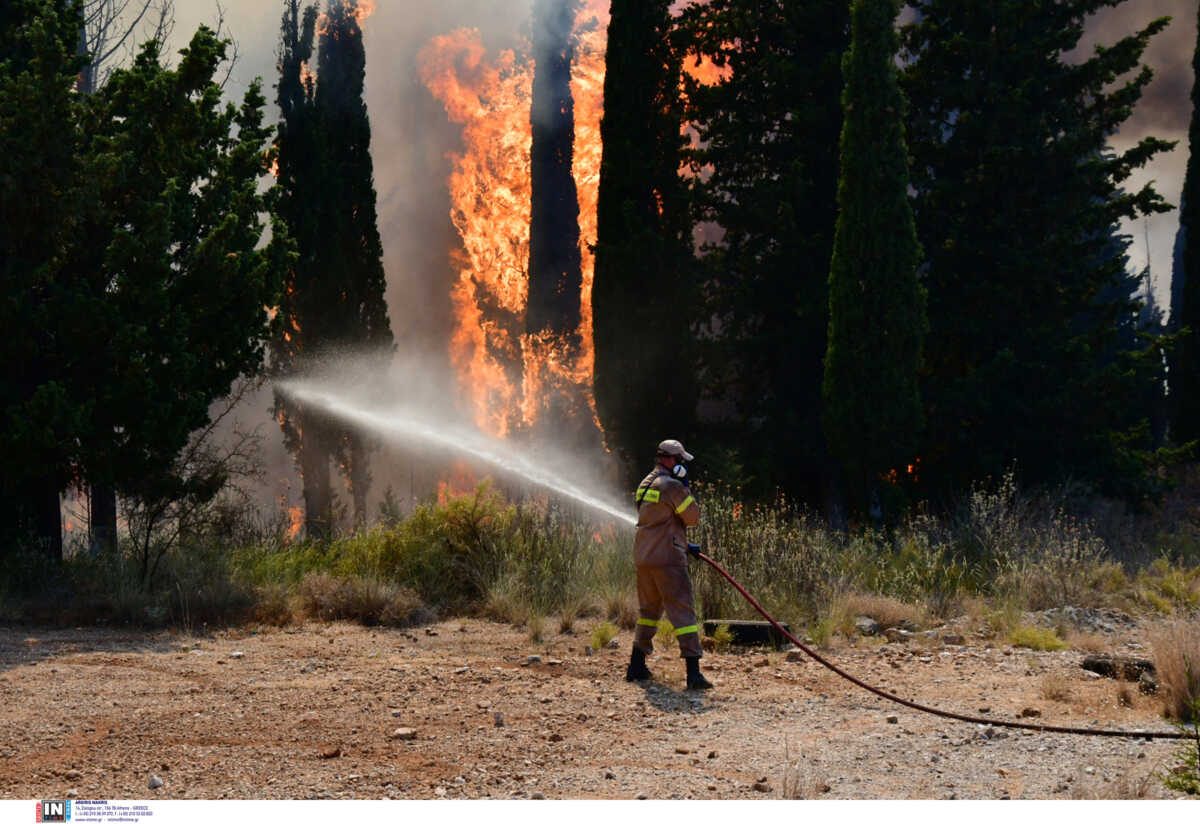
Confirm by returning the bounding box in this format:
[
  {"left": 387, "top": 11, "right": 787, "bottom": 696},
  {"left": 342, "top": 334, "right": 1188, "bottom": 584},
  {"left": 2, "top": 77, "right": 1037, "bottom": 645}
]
[{"left": 634, "top": 467, "right": 702, "bottom": 658}]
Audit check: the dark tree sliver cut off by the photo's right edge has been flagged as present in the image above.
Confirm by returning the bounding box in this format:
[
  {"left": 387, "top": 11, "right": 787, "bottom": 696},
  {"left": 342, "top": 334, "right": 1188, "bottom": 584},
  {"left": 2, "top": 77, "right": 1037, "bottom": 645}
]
[{"left": 1170, "top": 3, "right": 1200, "bottom": 444}]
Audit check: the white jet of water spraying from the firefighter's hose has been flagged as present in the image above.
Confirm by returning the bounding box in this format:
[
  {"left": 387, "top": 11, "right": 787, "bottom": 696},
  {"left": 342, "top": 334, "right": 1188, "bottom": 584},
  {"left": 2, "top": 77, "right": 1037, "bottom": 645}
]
[{"left": 277, "top": 381, "right": 637, "bottom": 527}]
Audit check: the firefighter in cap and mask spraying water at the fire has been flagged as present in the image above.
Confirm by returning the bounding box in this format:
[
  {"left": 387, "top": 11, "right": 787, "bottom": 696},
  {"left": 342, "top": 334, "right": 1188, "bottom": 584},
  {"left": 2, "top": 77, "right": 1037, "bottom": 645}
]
[{"left": 625, "top": 440, "right": 713, "bottom": 690}]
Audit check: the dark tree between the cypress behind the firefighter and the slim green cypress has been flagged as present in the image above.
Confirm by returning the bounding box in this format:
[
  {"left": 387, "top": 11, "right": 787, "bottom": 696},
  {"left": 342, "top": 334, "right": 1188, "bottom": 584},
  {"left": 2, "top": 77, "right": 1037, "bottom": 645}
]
[{"left": 679, "top": 0, "right": 850, "bottom": 504}]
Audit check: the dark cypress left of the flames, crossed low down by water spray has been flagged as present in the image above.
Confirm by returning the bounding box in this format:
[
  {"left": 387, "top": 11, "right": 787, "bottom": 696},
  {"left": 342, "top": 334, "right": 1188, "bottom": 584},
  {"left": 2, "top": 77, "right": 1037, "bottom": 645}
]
[{"left": 271, "top": 0, "right": 392, "bottom": 537}]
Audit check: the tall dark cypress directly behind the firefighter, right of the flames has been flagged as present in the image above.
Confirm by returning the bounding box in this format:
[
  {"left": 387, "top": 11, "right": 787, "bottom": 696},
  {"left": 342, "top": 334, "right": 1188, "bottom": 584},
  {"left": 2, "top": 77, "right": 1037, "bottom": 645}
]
[{"left": 592, "top": 0, "right": 696, "bottom": 481}]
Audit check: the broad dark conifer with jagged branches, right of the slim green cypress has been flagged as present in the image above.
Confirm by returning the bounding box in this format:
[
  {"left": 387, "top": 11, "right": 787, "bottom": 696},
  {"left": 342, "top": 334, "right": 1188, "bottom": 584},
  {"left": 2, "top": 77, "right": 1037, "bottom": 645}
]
[{"left": 901, "top": 0, "right": 1171, "bottom": 495}]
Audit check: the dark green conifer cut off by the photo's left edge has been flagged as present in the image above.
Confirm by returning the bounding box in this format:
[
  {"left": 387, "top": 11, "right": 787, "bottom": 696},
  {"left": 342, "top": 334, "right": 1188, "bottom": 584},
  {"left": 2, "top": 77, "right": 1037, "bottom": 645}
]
[{"left": 0, "top": 0, "right": 84, "bottom": 558}]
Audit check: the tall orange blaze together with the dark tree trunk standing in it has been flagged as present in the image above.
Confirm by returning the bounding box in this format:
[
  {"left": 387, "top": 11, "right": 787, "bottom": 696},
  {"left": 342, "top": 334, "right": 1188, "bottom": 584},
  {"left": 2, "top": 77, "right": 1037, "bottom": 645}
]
[{"left": 419, "top": 0, "right": 607, "bottom": 450}]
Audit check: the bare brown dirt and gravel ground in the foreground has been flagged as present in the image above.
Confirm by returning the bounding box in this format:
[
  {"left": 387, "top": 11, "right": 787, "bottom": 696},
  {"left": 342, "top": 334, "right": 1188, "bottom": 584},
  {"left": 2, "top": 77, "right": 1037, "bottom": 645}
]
[{"left": 0, "top": 620, "right": 1195, "bottom": 799}]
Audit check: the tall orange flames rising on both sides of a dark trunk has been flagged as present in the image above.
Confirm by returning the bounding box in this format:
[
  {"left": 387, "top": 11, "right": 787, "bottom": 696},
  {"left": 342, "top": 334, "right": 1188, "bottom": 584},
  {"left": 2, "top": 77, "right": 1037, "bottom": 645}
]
[{"left": 419, "top": 0, "right": 608, "bottom": 438}]
